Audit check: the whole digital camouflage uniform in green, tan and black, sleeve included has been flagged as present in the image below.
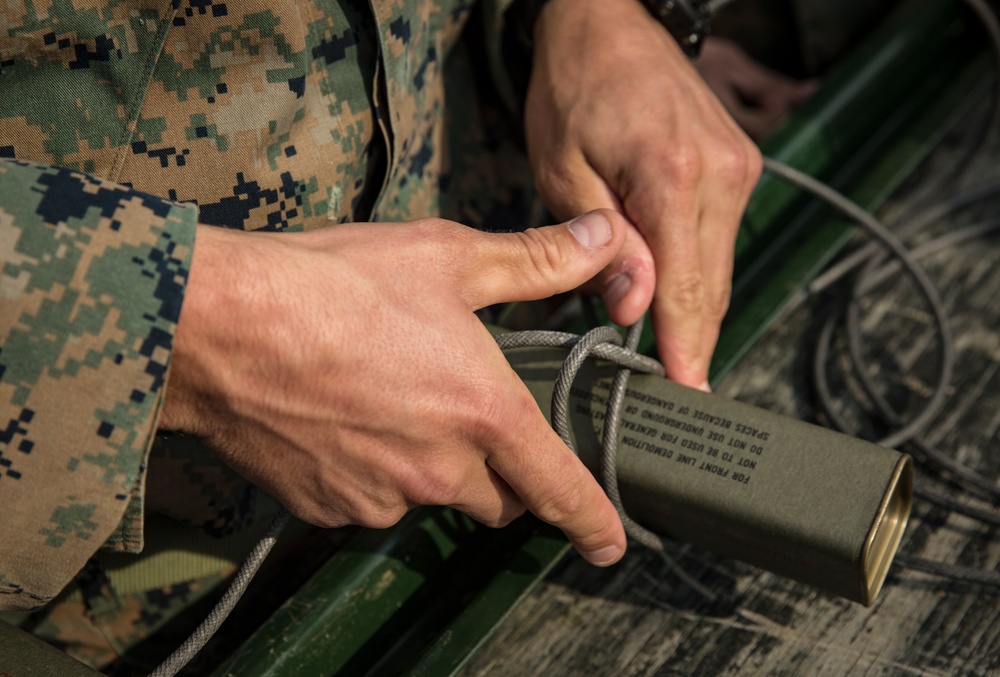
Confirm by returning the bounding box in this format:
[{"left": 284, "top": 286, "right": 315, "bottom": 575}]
[{"left": 0, "top": 0, "right": 542, "bottom": 665}]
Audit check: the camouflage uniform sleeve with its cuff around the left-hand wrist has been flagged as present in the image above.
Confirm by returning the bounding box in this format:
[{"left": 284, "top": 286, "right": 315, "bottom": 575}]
[{"left": 0, "top": 161, "right": 197, "bottom": 609}]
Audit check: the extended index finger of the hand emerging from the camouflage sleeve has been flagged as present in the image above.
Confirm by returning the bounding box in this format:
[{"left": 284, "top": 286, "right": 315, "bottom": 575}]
[{"left": 486, "top": 372, "right": 625, "bottom": 566}]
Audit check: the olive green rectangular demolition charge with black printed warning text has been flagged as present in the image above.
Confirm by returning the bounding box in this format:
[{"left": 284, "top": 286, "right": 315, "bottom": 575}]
[{"left": 506, "top": 348, "right": 913, "bottom": 606}]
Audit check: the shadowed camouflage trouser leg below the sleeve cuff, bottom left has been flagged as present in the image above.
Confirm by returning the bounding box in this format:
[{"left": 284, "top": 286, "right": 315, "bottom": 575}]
[{"left": 0, "top": 435, "right": 296, "bottom": 677}]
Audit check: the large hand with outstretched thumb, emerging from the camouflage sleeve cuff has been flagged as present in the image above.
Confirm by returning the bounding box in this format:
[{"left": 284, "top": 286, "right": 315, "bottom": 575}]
[{"left": 160, "top": 210, "right": 626, "bottom": 565}]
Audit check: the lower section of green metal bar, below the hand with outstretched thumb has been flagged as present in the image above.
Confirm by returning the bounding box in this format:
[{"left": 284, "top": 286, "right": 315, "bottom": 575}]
[{"left": 214, "top": 509, "right": 567, "bottom": 677}]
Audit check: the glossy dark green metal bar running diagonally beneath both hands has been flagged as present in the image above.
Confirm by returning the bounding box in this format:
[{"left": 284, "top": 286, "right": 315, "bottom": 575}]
[{"left": 207, "top": 0, "right": 988, "bottom": 677}]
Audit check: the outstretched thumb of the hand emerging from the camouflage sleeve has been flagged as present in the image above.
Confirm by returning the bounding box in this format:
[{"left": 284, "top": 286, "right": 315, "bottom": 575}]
[{"left": 462, "top": 209, "right": 627, "bottom": 310}]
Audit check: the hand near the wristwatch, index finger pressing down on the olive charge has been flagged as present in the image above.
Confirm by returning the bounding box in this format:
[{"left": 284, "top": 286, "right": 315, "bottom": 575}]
[{"left": 525, "top": 0, "right": 761, "bottom": 389}]
